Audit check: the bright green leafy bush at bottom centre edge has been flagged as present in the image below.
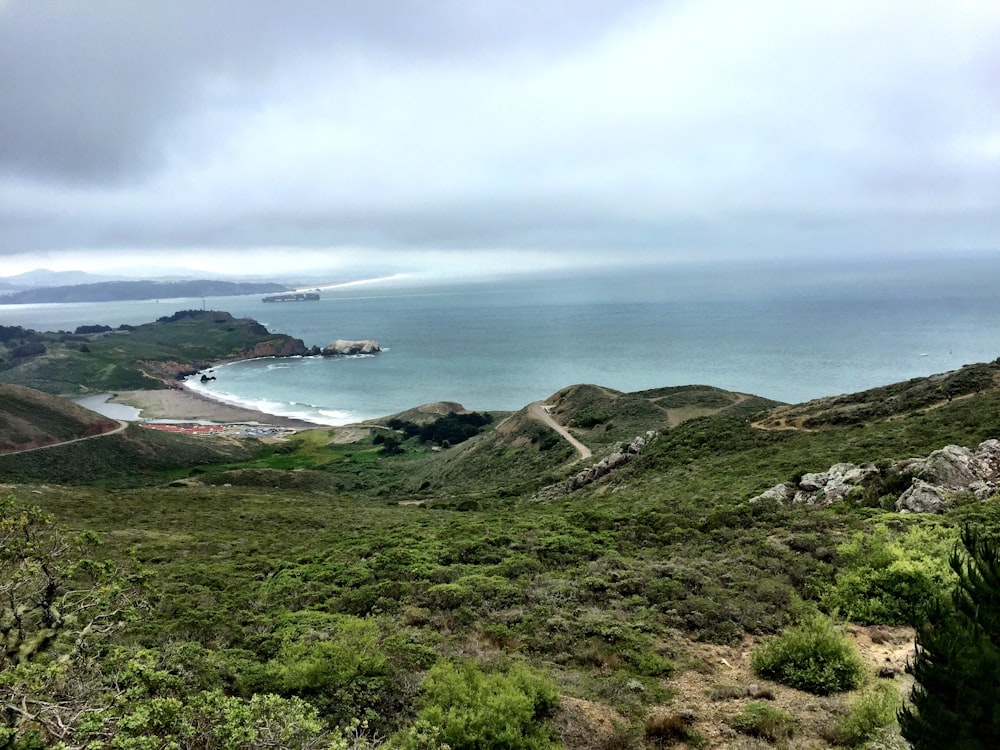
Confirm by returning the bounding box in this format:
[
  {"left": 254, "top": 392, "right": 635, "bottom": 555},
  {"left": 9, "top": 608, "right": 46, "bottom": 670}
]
[{"left": 398, "top": 662, "right": 558, "bottom": 750}]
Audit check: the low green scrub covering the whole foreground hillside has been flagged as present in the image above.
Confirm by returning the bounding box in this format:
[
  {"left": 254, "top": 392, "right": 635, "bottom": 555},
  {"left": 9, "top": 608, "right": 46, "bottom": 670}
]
[{"left": 0, "top": 340, "right": 1000, "bottom": 750}]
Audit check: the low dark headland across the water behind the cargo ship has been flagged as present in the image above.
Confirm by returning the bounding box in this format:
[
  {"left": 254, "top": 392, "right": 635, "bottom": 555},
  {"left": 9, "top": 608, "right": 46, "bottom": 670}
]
[{"left": 0, "top": 279, "right": 289, "bottom": 305}]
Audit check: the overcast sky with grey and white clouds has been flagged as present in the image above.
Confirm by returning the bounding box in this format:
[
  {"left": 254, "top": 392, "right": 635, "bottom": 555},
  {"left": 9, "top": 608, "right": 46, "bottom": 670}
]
[{"left": 0, "top": 0, "right": 1000, "bottom": 278}]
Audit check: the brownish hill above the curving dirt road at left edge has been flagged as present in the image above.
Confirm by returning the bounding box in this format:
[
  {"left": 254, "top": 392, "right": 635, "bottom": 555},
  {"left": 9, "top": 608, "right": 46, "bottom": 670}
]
[{"left": 0, "top": 384, "right": 118, "bottom": 453}]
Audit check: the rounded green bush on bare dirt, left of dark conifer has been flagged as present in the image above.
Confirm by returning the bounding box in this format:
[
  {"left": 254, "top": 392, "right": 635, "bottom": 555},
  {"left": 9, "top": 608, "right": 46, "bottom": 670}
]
[{"left": 750, "top": 615, "right": 865, "bottom": 695}]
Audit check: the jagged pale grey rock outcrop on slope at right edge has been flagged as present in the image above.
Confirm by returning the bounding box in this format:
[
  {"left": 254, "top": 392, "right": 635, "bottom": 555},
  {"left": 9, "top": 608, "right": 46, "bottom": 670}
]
[{"left": 750, "top": 440, "right": 1000, "bottom": 513}]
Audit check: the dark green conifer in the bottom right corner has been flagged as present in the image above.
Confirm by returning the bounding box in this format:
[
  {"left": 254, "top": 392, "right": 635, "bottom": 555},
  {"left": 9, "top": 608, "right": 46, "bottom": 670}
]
[{"left": 899, "top": 527, "right": 1000, "bottom": 750}]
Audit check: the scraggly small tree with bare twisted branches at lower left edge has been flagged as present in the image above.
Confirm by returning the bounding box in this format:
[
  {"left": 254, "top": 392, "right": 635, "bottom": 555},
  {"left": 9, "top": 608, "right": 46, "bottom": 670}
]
[{"left": 0, "top": 497, "right": 140, "bottom": 747}]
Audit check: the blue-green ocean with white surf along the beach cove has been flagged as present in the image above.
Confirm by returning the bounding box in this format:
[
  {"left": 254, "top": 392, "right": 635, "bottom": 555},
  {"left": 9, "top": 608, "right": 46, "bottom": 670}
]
[{"left": 0, "top": 258, "right": 1000, "bottom": 425}]
